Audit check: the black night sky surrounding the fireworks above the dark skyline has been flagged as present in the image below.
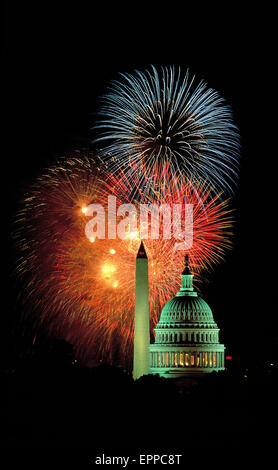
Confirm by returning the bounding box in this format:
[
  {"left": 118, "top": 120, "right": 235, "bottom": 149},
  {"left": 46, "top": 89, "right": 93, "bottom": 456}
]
[{"left": 1, "top": 2, "right": 277, "bottom": 363}]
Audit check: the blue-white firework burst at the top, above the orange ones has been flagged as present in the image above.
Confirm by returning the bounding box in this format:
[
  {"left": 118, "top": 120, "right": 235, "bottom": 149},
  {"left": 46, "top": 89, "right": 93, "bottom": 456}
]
[{"left": 94, "top": 66, "right": 239, "bottom": 194}]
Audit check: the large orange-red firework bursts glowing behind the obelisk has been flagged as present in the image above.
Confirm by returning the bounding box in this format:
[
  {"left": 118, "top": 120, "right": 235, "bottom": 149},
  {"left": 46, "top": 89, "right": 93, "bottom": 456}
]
[{"left": 15, "top": 152, "right": 235, "bottom": 369}]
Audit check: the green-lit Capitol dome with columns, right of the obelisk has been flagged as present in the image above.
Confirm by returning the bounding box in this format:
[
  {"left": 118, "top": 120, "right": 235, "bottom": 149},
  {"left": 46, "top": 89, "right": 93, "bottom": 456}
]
[{"left": 149, "top": 255, "right": 225, "bottom": 378}]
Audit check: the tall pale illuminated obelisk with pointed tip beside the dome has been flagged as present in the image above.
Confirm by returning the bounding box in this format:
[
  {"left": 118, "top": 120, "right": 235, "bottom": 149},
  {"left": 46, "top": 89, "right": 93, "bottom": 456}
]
[{"left": 133, "top": 242, "right": 150, "bottom": 380}]
